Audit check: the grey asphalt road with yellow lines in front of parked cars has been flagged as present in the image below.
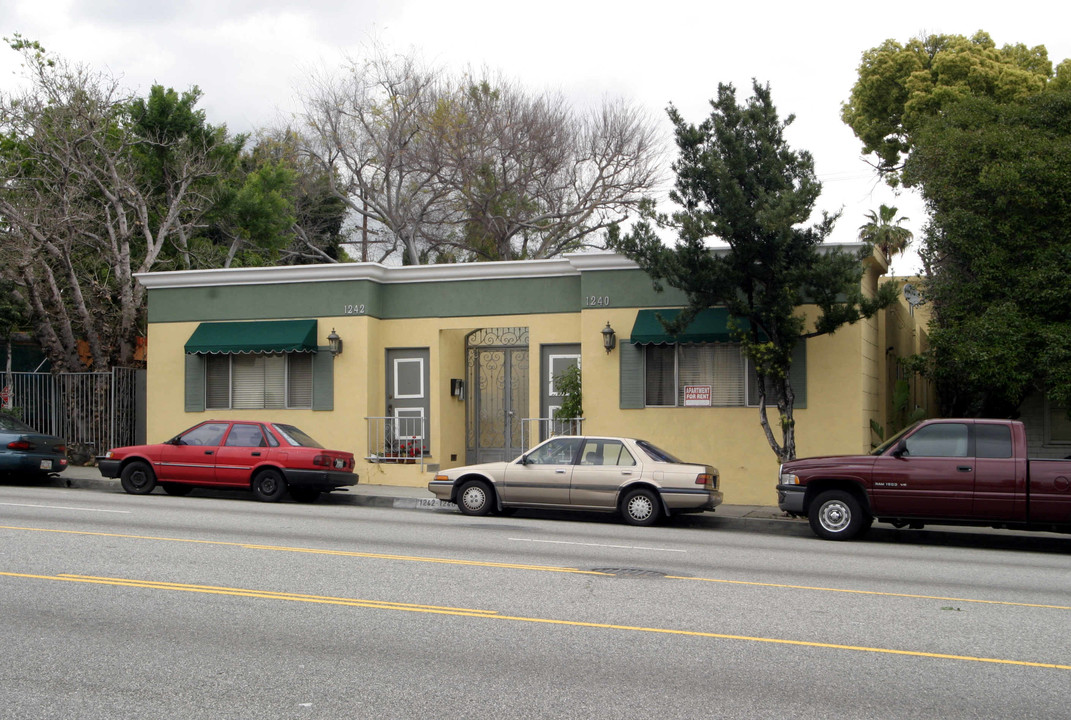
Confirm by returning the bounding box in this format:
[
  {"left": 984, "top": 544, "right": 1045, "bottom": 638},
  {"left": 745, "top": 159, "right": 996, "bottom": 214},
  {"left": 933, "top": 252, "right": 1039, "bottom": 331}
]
[{"left": 0, "top": 477, "right": 1071, "bottom": 720}]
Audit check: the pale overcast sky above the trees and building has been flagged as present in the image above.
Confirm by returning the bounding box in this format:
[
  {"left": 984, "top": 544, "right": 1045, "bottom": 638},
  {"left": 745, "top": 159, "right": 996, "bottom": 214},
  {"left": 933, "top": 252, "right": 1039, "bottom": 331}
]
[{"left": 0, "top": 0, "right": 1071, "bottom": 274}]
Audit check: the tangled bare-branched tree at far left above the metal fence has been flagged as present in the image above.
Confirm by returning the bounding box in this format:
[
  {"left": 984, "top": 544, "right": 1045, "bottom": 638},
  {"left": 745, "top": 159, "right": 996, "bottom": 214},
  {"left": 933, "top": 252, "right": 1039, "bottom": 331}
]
[{"left": 0, "top": 36, "right": 221, "bottom": 370}]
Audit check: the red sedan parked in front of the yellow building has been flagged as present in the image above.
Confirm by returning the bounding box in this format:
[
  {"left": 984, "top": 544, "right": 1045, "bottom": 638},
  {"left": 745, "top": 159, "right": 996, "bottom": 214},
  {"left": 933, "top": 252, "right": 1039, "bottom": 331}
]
[{"left": 96, "top": 420, "right": 358, "bottom": 503}]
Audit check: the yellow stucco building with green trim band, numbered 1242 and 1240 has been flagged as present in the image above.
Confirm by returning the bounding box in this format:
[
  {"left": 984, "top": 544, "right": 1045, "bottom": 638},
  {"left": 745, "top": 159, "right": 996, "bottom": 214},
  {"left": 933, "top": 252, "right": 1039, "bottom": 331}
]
[{"left": 139, "top": 247, "right": 929, "bottom": 505}]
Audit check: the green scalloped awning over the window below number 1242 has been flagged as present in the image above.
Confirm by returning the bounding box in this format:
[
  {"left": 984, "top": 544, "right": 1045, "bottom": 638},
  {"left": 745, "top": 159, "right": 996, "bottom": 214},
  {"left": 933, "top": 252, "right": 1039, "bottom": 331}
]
[{"left": 186, "top": 320, "right": 316, "bottom": 355}]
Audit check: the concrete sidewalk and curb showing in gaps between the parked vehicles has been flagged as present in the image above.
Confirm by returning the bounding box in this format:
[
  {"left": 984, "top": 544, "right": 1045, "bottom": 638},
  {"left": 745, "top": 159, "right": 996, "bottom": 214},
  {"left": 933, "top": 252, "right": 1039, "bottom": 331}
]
[{"left": 52, "top": 465, "right": 799, "bottom": 522}]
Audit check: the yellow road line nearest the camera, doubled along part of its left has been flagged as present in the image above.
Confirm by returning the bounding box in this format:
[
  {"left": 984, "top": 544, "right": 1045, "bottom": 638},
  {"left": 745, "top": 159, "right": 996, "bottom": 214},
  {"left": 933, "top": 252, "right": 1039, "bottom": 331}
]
[{"left": 0, "top": 572, "right": 1071, "bottom": 670}]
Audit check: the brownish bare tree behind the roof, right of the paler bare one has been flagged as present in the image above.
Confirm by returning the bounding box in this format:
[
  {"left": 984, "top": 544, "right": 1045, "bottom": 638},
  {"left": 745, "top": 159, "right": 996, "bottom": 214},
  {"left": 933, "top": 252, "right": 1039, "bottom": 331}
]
[{"left": 449, "top": 78, "right": 660, "bottom": 260}]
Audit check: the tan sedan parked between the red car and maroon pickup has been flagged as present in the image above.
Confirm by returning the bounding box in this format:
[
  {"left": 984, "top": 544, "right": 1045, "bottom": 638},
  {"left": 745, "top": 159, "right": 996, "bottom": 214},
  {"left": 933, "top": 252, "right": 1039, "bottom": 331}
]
[{"left": 427, "top": 436, "right": 722, "bottom": 525}]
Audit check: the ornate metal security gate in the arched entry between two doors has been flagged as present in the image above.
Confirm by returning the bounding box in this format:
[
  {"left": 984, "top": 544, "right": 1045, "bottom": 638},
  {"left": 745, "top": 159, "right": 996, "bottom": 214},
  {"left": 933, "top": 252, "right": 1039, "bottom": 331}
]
[{"left": 465, "top": 328, "right": 528, "bottom": 463}]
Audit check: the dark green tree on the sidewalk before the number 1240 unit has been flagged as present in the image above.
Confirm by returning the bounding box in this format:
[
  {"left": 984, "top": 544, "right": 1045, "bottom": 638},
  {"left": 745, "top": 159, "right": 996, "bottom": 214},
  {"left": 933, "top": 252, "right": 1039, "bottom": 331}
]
[{"left": 610, "top": 83, "right": 895, "bottom": 462}]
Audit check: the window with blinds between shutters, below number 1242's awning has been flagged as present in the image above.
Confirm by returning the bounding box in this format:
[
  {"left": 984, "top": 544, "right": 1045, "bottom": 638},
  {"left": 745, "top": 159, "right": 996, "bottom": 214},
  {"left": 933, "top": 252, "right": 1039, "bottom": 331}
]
[{"left": 205, "top": 353, "right": 313, "bottom": 409}]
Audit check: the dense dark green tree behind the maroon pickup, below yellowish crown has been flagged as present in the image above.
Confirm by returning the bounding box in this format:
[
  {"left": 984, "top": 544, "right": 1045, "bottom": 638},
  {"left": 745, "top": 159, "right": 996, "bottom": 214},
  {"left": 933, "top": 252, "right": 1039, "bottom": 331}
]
[{"left": 904, "top": 91, "right": 1071, "bottom": 417}]
